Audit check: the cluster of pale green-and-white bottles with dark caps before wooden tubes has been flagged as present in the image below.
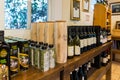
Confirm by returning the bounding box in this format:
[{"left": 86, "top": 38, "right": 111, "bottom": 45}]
[{"left": 30, "top": 41, "right": 55, "bottom": 72}]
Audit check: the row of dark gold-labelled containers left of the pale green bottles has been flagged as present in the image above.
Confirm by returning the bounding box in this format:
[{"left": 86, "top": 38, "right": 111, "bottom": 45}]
[{"left": 5, "top": 36, "right": 30, "bottom": 76}]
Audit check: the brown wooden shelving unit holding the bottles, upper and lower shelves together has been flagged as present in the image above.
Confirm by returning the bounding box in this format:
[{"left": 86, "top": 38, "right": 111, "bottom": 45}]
[{"left": 12, "top": 42, "right": 112, "bottom": 80}]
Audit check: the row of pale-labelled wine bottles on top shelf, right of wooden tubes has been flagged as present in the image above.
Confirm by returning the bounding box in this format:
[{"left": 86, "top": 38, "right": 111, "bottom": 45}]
[{"left": 68, "top": 26, "right": 109, "bottom": 58}]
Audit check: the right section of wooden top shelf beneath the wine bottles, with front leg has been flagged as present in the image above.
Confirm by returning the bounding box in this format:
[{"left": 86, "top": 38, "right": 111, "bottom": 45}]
[{"left": 63, "top": 42, "right": 112, "bottom": 80}]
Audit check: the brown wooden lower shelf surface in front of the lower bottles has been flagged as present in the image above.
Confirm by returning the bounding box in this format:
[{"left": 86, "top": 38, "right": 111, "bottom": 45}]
[{"left": 88, "top": 62, "right": 111, "bottom": 80}]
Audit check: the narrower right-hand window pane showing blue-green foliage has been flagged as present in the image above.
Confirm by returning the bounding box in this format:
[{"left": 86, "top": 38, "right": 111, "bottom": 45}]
[{"left": 31, "top": 0, "right": 48, "bottom": 22}]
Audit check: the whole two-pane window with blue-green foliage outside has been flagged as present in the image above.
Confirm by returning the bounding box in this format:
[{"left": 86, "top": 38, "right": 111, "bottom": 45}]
[{"left": 5, "top": 0, "right": 48, "bottom": 29}]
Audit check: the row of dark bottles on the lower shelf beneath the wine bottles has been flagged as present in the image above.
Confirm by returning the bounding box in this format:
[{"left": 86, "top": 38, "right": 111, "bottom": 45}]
[{"left": 70, "top": 49, "right": 110, "bottom": 80}]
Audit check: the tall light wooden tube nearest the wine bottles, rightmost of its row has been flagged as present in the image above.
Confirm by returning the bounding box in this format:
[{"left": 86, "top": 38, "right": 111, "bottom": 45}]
[{"left": 54, "top": 21, "right": 67, "bottom": 63}]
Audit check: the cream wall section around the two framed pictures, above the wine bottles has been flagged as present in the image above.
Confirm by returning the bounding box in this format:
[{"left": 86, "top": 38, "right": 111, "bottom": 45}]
[{"left": 62, "top": 0, "right": 93, "bottom": 25}]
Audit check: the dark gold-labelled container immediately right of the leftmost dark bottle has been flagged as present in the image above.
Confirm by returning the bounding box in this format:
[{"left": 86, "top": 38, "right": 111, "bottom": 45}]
[{"left": 5, "top": 39, "right": 20, "bottom": 76}]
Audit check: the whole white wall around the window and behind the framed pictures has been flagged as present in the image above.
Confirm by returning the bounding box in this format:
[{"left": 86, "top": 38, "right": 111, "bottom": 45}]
[{"left": 0, "top": 0, "right": 93, "bottom": 39}]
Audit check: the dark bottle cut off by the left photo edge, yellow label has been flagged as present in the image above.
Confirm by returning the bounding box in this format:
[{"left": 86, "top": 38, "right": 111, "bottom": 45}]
[{"left": 0, "top": 31, "right": 10, "bottom": 80}]
